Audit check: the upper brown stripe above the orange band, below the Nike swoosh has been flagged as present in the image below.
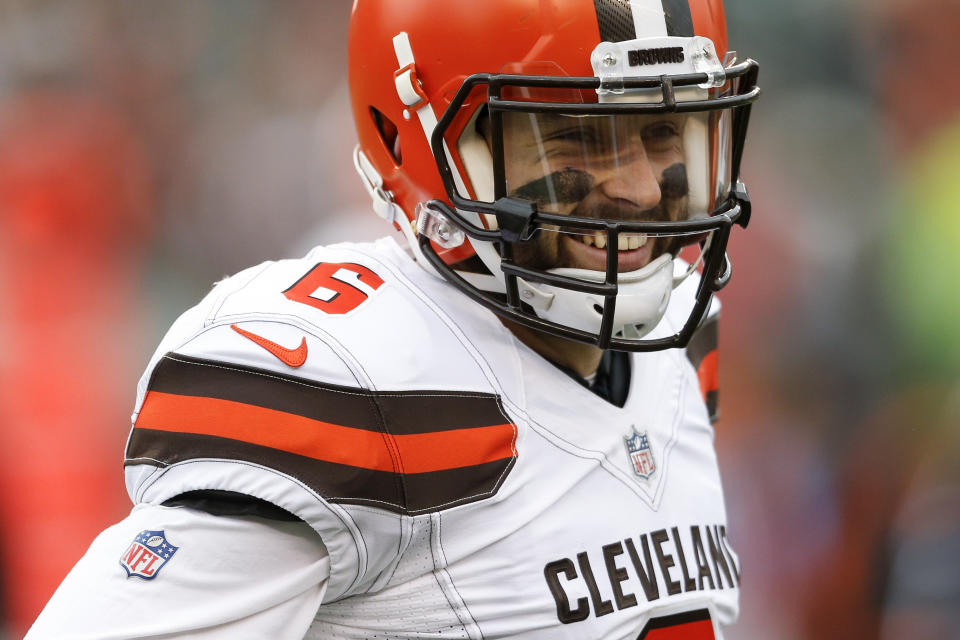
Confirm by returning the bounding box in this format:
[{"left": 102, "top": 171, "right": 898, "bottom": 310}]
[{"left": 149, "top": 354, "right": 506, "bottom": 435}]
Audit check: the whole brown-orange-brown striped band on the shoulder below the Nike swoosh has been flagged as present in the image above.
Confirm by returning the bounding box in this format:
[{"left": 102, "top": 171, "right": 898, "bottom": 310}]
[{"left": 127, "top": 354, "right": 516, "bottom": 513}]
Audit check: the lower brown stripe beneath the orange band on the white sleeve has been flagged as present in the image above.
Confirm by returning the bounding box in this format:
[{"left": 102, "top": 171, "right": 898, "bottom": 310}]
[{"left": 127, "top": 428, "right": 515, "bottom": 515}]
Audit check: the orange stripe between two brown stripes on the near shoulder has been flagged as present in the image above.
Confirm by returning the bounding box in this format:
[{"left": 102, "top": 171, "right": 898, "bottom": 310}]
[{"left": 136, "top": 391, "right": 515, "bottom": 473}]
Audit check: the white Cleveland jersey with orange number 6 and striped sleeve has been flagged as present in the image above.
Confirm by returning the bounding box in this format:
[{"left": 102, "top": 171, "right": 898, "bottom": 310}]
[{"left": 29, "top": 240, "right": 740, "bottom": 640}]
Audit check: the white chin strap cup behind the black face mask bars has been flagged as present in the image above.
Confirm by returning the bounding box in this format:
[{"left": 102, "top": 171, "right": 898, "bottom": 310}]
[{"left": 518, "top": 254, "right": 680, "bottom": 338}]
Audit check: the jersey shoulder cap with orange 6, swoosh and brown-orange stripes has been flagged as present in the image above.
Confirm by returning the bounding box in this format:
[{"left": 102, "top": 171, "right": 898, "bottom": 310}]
[{"left": 125, "top": 243, "right": 516, "bottom": 598}]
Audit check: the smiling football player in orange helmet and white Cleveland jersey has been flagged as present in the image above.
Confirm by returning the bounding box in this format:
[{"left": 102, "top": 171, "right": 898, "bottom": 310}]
[{"left": 28, "top": 0, "right": 758, "bottom": 640}]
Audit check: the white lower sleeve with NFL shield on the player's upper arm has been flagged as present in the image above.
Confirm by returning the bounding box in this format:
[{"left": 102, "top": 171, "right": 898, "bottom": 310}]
[{"left": 27, "top": 505, "right": 330, "bottom": 640}]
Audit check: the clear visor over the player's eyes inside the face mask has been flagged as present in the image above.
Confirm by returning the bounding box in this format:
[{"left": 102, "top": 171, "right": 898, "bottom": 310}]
[{"left": 502, "top": 110, "right": 731, "bottom": 228}]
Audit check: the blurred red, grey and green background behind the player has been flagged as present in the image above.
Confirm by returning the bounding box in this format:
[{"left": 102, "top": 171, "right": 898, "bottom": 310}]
[{"left": 0, "top": 0, "right": 960, "bottom": 640}]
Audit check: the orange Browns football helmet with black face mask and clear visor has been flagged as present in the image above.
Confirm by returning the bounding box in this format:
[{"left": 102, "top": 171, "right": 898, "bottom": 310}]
[{"left": 349, "top": 0, "right": 759, "bottom": 351}]
